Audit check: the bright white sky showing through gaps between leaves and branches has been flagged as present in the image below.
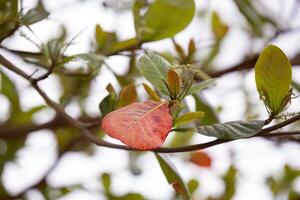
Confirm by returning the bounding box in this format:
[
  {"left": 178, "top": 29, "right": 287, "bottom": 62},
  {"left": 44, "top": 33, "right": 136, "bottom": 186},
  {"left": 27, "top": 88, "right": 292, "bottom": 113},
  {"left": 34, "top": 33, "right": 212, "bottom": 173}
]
[{"left": 0, "top": 0, "right": 300, "bottom": 200}]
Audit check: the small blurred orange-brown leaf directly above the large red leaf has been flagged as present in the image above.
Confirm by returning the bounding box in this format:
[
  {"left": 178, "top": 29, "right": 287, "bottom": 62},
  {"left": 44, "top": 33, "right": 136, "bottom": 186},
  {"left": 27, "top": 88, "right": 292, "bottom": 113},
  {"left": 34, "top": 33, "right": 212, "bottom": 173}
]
[{"left": 117, "top": 84, "right": 137, "bottom": 108}]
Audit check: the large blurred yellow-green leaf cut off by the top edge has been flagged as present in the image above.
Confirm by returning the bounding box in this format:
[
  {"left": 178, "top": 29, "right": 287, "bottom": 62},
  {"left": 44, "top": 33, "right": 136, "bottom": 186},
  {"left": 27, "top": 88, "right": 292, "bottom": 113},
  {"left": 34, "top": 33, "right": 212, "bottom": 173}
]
[{"left": 134, "top": 0, "right": 195, "bottom": 41}]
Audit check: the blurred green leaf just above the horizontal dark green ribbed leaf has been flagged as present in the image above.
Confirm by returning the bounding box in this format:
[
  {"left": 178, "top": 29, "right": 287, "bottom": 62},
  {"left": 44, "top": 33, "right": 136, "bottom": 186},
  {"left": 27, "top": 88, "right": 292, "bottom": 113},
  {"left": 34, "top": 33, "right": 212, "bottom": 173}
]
[{"left": 193, "top": 94, "right": 220, "bottom": 125}]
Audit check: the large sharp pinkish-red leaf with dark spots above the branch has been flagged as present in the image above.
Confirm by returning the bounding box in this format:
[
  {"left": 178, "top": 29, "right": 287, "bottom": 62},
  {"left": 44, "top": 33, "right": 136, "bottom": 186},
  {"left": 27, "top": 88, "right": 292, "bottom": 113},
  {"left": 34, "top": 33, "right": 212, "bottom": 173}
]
[{"left": 101, "top": 100, "right": 172, "bottom": 150}]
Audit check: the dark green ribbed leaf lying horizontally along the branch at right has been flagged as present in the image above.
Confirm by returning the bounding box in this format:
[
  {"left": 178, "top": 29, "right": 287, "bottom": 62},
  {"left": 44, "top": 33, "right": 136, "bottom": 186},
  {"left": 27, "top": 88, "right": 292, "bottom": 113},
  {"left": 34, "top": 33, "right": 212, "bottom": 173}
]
[{"left": 196, "top": 120, "right": 264, "bottom": 139}]
